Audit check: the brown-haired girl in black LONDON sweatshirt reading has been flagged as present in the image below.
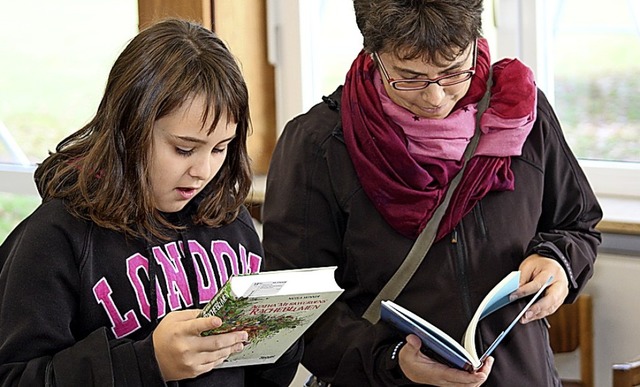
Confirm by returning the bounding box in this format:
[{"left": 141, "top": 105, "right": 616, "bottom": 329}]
[{"left": 0, "top": 19, "right": 301, "bottom": 387}]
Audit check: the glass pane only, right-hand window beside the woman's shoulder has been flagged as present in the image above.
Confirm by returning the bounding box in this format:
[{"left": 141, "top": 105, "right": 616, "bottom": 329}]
[{"left": 553, "top": 0, "right": 640, "bottom": 162}]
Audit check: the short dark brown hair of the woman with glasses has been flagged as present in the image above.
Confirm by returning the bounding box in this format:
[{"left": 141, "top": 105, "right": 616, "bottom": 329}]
[{"left": 353, "top": 0, "right": 483, "bottom": 63}]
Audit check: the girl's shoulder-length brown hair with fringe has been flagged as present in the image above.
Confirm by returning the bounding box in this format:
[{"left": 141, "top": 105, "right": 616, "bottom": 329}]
[{"left": 35, "top": 19, "right": 251, "bottom": 242}]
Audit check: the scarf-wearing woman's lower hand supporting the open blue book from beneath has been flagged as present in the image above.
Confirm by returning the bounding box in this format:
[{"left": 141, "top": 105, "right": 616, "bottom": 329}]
[{"left": 399, "top": 335, "right": 493, "bottom": 386}]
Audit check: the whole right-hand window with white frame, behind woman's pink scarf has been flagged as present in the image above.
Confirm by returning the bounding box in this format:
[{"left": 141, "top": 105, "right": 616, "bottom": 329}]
[{"left": 495, "top": 0, "right": 640, "bottom": 199}]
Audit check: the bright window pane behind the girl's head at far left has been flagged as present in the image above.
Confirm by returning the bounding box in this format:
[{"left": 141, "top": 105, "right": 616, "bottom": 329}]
[{"left": 0, "top": 0, "right": 138, "bottom": 163}]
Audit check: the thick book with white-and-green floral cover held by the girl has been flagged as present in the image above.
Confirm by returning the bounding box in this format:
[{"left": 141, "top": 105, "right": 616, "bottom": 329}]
[{"left": 200, "top": 266, "right": 343, "bottom": 368}]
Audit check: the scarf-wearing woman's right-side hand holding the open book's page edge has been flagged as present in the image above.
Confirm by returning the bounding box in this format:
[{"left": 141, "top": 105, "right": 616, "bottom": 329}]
[{"left": 512, "top": 254, "right": 569, "bottom": 324}]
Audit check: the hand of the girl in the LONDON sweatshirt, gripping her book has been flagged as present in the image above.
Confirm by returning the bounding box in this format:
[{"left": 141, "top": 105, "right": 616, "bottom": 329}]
[{"left": 153, "top": 309, "right": 248, "bottom": 381}]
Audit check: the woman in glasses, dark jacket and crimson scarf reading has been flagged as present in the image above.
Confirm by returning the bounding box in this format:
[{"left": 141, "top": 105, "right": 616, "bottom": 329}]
[{"left": 263, "top": 0, "right": 601, "bottom": 386}]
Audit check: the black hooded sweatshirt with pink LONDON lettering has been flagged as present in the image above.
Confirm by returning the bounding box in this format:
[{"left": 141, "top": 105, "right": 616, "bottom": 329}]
[{"left": 0, "top": 198, "right": 301, "bottom": 387}]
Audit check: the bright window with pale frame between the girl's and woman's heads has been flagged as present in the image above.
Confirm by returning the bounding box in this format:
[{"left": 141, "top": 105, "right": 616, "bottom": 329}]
[{"left": 267, "top": 0, "right": 362, "bottom": 133}]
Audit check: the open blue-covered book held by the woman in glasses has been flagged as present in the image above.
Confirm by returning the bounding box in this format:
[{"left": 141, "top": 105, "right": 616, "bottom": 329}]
[{"left": 380, "top": 271, "right": 553, "bottom": 372}]
